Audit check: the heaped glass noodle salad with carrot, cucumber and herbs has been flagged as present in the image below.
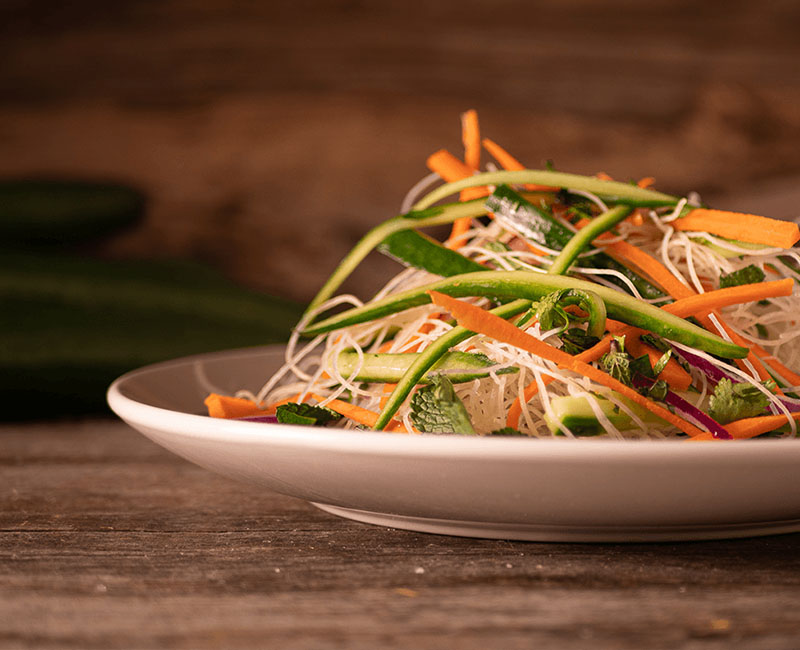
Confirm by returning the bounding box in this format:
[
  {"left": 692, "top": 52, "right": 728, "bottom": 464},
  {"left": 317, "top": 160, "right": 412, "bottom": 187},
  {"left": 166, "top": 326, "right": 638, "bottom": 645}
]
[{"left": 206, "top": 111, "right": 800, "bottom": 440}]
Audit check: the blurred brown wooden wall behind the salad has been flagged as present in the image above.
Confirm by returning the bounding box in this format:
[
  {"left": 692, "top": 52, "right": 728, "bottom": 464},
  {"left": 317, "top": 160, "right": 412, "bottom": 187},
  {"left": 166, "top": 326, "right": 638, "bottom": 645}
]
[{"left": 0, "top": 0, "right": 800, "bottom": 299}]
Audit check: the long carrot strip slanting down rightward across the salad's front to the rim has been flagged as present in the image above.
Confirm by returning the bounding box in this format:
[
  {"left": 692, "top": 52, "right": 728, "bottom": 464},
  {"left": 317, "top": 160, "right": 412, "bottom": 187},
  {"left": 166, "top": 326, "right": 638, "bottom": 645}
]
[{"left": 428, "top": 291, "right": 702, "bottom": 436}]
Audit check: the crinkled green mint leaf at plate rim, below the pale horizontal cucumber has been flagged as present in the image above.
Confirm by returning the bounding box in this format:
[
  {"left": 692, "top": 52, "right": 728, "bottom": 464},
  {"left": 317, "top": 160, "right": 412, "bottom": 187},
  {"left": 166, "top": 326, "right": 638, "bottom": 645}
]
[{"left": 411, "top": 375, "right": 477, "bottom": 435}]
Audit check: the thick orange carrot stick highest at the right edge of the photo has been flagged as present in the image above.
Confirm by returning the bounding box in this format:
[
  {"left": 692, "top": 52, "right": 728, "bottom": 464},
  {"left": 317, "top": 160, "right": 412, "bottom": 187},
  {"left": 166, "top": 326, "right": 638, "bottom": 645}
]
[{"left": 671, "top": 208, "right": 800, "bottom": 248}]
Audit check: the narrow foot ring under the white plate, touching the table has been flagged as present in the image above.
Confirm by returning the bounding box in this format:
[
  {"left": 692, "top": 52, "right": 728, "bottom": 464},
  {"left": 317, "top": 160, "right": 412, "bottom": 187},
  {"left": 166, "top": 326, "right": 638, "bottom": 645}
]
[{"left": 313, "top": 503, "right": 800, "bottom": 542}]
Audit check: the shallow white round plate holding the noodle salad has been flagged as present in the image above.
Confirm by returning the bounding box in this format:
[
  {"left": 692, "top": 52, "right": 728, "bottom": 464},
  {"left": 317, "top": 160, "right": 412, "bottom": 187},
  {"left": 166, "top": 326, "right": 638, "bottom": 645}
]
[{"left": 108, "top": 347, "right": 800, "bottom": 542}]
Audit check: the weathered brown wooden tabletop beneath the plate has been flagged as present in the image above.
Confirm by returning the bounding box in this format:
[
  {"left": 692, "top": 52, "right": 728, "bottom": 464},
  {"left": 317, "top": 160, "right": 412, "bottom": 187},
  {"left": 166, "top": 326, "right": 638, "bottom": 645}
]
[{"left": 0, "top": 419, "right": 800, "bottom": 649}]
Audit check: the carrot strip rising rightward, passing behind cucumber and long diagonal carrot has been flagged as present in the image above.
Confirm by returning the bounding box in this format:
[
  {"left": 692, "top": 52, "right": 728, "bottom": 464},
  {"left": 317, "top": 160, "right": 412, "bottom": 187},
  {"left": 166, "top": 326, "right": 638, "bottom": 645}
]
[{"left": 506, "top": 278, "right": 793, "bottom": 428}]
